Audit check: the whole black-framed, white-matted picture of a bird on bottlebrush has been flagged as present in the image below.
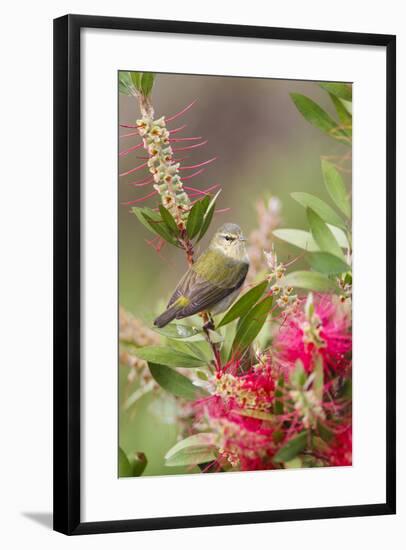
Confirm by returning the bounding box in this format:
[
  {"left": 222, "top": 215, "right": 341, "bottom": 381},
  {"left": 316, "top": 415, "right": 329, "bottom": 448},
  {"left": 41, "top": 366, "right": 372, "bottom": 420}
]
[{"left": 54, "top": 15, "right": 396, "bottom": 535}]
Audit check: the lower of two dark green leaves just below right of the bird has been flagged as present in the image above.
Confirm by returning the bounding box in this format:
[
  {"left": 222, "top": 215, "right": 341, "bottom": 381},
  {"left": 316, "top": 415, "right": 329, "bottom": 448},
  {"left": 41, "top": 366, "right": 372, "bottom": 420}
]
[{"left": 230, "top": 296, "right": 273, "bottom": 356}]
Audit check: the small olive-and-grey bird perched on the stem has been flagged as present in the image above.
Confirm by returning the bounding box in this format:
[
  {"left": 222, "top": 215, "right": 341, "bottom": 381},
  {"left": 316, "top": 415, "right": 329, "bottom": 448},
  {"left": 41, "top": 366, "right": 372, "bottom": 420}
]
[{"left": 154, "top": 223, "right": 249, "bottom": 328}]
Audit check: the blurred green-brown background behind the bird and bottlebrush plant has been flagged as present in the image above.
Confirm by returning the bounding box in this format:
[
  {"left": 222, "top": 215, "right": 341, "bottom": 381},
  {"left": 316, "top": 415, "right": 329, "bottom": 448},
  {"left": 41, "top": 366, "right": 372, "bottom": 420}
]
[{"left": 118, "top": 73, "right": 348, "bottom": 475}]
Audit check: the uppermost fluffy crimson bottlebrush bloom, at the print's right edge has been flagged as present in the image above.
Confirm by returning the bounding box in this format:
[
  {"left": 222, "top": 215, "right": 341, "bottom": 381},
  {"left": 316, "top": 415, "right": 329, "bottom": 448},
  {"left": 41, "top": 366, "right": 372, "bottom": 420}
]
[{"left": 274, "top": 295, "right": 352, "bottom": 373}]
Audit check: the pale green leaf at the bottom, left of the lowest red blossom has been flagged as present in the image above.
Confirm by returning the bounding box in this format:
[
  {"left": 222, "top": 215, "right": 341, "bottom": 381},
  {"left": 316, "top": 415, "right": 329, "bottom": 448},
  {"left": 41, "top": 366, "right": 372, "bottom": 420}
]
[{"left": 165, "top": 433, "right": 216, "bottom": 466}]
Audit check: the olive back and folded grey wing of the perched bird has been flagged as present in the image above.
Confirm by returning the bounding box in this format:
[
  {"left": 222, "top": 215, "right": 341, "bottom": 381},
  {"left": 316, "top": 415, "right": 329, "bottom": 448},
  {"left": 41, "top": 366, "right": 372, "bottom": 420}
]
[{"left": 168, "top": 250, "right": 248, "bottom": 319}]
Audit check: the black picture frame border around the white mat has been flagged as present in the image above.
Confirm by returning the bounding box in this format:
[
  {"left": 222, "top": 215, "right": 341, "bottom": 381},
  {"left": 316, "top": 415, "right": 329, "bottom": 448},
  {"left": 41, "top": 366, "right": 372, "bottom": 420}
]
[{"left": 53, "top": 15, "right": 396, "bottom": 535}]
